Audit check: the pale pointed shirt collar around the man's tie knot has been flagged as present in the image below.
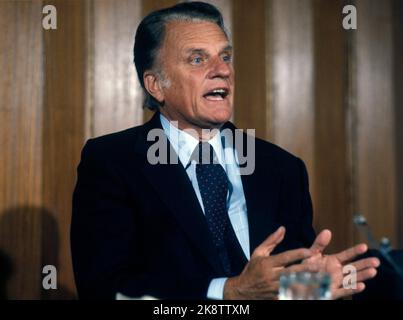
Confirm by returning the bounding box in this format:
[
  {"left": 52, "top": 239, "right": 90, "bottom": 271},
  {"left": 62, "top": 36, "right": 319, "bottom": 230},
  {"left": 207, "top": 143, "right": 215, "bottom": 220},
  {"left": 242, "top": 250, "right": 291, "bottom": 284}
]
[{"left": 160, "top": 113, "right": 224, "bottom": 168}]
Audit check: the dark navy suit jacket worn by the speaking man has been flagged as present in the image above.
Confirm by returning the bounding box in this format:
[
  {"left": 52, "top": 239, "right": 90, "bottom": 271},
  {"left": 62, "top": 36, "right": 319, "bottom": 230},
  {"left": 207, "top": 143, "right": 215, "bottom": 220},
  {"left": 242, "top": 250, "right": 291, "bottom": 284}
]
[{"left": 71, "top": 112, "right": 315, "bottom": 299}]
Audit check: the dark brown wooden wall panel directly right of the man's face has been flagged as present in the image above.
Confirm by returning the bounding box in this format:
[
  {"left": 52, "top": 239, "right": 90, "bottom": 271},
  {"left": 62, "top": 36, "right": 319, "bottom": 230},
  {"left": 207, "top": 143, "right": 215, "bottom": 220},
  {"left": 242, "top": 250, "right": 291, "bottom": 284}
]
[{"left": 232, "top": 0, "right": 269, "bottom": 138}]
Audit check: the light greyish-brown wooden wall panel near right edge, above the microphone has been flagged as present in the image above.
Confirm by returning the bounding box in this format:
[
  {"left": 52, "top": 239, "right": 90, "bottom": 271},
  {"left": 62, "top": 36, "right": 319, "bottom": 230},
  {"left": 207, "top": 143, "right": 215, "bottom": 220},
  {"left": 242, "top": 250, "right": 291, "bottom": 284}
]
[{"left": 355, "top": 0, "right": 397, "bottom": 244}]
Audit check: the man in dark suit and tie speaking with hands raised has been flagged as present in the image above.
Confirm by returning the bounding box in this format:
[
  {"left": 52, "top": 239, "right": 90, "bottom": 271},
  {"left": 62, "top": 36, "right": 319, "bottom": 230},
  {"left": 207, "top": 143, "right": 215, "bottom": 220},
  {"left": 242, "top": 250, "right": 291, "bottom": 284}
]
[{"left": 71, "top": 2, "right": 379, "bottom": 299}]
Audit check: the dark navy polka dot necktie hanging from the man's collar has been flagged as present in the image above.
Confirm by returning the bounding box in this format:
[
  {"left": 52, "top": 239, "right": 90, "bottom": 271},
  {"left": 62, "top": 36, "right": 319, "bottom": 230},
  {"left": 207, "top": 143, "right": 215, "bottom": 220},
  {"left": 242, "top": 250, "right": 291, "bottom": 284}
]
[{"left": 195, "top": 142, "right": 233, "bottom": 276}]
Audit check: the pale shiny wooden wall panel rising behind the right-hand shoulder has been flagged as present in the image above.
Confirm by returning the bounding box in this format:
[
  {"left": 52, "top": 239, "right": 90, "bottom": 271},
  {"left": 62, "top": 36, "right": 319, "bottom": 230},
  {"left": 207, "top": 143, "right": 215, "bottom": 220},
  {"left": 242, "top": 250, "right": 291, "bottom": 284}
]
[{"left": 269, "top": 0, "right": 316, "bottom": 211}]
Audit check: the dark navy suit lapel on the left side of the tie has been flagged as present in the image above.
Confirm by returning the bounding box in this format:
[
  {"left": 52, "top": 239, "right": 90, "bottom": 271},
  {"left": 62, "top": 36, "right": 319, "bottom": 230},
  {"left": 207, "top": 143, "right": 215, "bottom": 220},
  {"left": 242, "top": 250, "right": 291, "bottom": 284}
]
[{"left": 138, "top": 112, "right": 223, "bottom": 274}]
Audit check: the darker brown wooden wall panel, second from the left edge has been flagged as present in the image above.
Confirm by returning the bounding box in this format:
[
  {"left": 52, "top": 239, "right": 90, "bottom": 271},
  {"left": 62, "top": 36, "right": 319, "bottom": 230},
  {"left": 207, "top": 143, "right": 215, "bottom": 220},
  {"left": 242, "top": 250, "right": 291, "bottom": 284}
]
[{"left": 42, "top": 0, "right": 87, "bottom": 298}]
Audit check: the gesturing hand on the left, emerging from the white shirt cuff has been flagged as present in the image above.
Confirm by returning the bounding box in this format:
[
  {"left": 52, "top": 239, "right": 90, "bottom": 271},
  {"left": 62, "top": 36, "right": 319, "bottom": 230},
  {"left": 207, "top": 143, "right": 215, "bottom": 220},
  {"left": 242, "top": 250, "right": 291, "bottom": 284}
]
[{"left": 224, "top": 227, "right": 316, "bottom": 299}]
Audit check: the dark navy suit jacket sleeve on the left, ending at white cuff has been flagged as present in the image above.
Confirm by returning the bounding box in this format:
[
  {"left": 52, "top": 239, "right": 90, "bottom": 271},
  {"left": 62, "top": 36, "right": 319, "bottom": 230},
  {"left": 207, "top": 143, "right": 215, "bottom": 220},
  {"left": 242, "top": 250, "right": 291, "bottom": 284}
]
[{"left": 71, "top": 140, "right": 211, "bottom": 299}]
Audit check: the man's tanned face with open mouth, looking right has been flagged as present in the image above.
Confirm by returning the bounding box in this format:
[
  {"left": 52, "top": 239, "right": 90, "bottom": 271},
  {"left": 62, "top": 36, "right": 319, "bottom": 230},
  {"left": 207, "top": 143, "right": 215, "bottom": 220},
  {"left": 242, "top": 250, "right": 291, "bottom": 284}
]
[{"left": 152, "top": 22, "right": 234, "bottom": 129}]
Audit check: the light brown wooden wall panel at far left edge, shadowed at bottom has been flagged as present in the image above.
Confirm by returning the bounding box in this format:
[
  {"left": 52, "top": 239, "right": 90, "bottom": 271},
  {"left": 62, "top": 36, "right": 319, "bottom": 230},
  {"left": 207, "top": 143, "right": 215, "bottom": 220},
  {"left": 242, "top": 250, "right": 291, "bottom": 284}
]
[{"left": 0, "top": 1, "right": 43, "bottom": 299}]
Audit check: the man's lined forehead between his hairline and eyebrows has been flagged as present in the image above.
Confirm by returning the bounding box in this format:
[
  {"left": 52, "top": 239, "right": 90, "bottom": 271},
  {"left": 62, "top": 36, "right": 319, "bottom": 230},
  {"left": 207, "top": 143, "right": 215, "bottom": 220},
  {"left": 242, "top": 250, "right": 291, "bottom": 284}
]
[{"left": 164, "top": 21, "right": 229, "bottom": 51}]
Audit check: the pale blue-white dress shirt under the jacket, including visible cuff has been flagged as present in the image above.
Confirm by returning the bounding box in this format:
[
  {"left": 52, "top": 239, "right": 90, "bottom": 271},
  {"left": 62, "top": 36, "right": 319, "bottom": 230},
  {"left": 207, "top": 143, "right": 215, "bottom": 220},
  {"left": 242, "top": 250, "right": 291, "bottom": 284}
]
[{"left": 160, "top": 114, "right": 250, "bottom": 299}]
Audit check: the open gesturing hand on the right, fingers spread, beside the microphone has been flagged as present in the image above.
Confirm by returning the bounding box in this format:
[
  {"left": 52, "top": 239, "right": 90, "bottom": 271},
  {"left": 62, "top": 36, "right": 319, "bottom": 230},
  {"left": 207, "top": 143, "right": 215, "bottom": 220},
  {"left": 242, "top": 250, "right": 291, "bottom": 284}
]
[{"left": 303, "top": 230, "right": 380, "bottom": 299}]
